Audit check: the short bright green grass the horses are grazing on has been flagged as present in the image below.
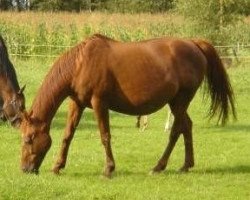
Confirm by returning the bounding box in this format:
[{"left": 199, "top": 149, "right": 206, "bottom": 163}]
[{"left": 0, "top": 59, "right": 250, "bottom": 200}]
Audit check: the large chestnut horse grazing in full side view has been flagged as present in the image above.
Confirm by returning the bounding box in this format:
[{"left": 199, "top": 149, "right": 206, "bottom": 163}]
[{"left": 20, "top": 34, "right": 236, "bottom": 177}]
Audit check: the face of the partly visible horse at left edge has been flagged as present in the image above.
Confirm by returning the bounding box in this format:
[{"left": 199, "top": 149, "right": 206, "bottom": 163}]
[{"left": 2, "top": 87, "right": 25, "bottom": 127}]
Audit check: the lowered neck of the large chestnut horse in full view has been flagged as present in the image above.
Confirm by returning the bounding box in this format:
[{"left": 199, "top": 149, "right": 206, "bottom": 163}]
[{"left": 31, "top": 63, "right": 71, "bottom": 126}]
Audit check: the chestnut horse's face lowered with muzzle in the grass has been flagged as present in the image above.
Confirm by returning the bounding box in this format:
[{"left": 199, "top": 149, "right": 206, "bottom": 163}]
[{"left": 20, "top": 115, "right": 51, "bottom": 174}]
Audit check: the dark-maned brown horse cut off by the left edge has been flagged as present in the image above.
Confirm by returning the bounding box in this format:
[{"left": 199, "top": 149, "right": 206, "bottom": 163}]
[{"left": 0, "top": 35, "right": 25, "bottom": 126}]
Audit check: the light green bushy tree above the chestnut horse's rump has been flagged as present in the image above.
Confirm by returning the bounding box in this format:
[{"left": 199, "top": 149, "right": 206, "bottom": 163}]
[{"left": 176, "top": 0, "right": 250, "bottom": 44}]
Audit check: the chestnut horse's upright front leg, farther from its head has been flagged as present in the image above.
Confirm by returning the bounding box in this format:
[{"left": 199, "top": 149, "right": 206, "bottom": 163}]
[{"left": 91, "top": 97, "right": 115, "bottom": 178}]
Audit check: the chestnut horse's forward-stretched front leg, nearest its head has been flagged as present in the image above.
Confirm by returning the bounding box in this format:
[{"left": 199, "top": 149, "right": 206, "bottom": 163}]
[{"left": 52, "top": 99, "right": 83, "bottom": 174}]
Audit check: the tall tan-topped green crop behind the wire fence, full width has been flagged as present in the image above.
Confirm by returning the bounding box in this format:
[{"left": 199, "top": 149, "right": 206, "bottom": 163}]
[{"left": 0, "top": 12, "right": 250, "bottom": 56}]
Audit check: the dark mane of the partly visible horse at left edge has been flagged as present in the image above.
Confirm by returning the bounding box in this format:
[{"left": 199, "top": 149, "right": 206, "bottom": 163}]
[{"left": 0, "top": 35, "right": 20, "bottom": 90}]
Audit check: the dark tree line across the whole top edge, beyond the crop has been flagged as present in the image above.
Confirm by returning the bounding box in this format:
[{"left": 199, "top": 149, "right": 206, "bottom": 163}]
[{"left": 0, "top": 0, "right": 250, "bottom": 15}]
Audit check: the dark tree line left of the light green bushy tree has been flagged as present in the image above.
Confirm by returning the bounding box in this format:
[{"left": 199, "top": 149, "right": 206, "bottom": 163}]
[{"left": 0, "top": 0, "right": 175, "bottom": 13}]
